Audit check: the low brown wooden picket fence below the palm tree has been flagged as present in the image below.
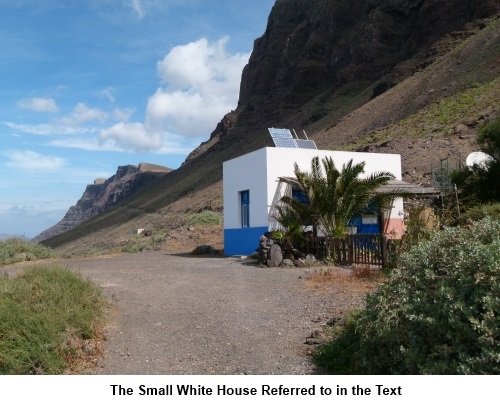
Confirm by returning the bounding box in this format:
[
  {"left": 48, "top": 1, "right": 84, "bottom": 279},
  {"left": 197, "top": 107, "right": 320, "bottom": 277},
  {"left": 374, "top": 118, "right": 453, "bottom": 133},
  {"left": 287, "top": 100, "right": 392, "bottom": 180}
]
[{"left": 305, "top": 234, "right": 390, "bottom": 267}]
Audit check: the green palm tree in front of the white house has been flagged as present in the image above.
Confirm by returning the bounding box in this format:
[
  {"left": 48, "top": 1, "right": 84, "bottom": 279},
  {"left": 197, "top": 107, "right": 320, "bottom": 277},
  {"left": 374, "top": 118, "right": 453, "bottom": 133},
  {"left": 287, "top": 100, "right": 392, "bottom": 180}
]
[{"left": 282, "top": 157, "right": 405, "bottom": 237}]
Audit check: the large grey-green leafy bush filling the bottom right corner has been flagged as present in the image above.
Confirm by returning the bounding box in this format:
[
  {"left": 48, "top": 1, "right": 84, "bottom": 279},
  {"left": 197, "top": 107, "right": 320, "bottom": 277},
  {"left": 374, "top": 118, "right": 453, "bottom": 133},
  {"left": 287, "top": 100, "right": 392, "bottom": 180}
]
[{"left": 316, "top": 218, "right": 500, "bottom": 374}]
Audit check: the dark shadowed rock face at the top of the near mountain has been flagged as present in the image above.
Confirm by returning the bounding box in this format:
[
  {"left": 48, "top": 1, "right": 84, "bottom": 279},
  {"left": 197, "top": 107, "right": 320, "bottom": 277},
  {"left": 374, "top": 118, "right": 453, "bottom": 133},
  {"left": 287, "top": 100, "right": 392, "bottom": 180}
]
[{"left": 239, "top": 0, "right": 500, "bottom": 117}]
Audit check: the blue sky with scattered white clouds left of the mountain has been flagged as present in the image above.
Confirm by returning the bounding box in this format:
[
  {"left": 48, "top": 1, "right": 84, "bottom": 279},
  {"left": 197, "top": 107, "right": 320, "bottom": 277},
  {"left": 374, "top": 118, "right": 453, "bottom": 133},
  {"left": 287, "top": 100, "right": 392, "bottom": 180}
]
[{"left": 0, "top": 0, "right": 274, "bottom": 237}]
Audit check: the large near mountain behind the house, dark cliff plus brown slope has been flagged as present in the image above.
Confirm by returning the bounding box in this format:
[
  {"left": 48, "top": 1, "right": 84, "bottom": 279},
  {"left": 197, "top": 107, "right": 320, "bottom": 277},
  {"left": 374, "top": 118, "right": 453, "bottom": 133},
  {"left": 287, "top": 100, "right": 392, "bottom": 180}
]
[{"left": 45, "top": 0, "right": 500, "bottom": 252}]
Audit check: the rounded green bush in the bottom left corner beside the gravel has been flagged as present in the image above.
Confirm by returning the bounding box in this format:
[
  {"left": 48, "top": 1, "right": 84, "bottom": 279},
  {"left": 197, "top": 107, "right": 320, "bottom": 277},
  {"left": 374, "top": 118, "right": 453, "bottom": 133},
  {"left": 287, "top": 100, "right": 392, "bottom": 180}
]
[{"left": 0, "top": 266, "right": 106, "bottom": 374}]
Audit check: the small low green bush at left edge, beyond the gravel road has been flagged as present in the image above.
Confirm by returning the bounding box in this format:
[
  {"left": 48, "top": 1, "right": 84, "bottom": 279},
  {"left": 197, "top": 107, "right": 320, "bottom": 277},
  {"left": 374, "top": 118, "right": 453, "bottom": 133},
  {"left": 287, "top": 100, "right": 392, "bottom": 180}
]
[{"left": 0, "top": 238, "right": 55, "bottom": 264}]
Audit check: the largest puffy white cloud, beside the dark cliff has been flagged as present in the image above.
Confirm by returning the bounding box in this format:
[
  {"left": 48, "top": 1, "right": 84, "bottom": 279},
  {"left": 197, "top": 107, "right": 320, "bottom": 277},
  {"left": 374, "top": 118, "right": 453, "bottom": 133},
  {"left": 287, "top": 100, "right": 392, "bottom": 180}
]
[{"left": 146, "top": 37, "right": 249, "bottom": 137}]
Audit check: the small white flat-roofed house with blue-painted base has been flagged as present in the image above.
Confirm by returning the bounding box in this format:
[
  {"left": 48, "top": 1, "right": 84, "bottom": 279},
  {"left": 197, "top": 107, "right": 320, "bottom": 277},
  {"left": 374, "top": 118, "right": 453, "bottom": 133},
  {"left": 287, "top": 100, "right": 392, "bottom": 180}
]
[{"left": 223, "top": 147, "right": 404, "bottom": 255}]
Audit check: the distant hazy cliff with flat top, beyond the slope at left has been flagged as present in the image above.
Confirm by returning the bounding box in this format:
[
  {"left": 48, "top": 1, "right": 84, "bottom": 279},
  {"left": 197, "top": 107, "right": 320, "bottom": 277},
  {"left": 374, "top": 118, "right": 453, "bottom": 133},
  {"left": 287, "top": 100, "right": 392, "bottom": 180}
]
[{"left": 33, "top": 163, "right": 172, "bottom": 242}]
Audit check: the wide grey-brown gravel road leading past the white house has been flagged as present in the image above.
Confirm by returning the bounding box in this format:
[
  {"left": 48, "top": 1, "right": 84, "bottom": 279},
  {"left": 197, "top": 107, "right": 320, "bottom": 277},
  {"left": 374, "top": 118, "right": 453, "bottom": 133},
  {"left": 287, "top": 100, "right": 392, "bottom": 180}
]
[{"left": 4, "top": 252, "right": 368, "bottom": 375}]
